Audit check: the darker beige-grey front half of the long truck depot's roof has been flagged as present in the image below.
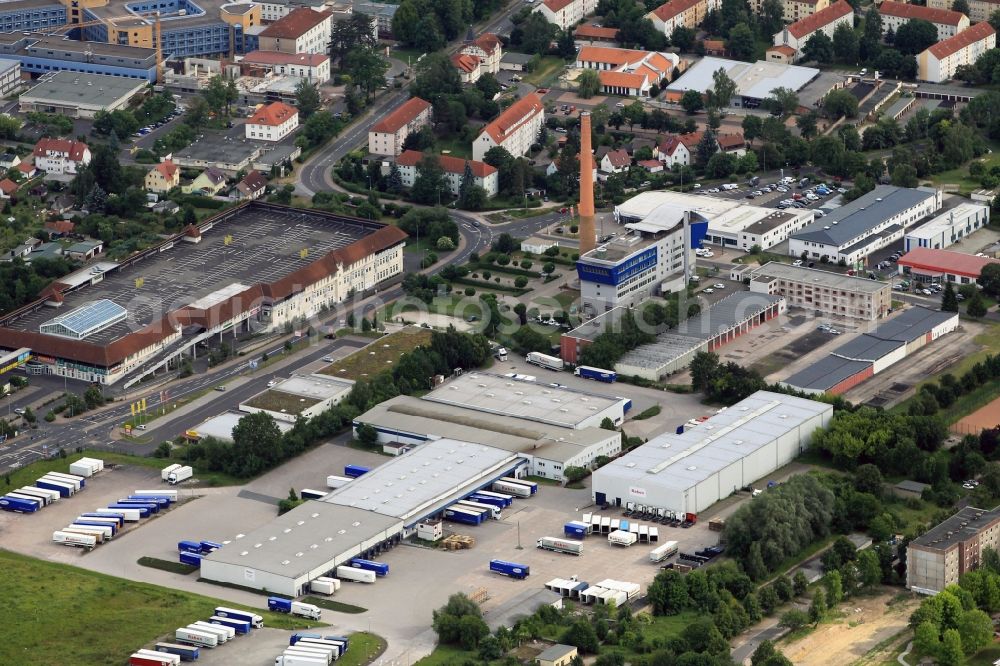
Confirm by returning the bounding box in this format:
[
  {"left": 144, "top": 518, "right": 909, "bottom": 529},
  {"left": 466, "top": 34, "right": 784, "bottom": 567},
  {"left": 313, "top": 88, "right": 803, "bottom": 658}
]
[{"left": 205, "top": 504, "right": 402, "bottom": 578}]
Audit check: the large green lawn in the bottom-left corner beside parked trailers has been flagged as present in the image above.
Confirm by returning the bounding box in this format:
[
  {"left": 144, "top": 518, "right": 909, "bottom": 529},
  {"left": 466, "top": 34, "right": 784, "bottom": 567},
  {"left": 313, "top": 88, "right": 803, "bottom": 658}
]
[{"left": 0, "top": 551, "right": 324, "bottom": 666}]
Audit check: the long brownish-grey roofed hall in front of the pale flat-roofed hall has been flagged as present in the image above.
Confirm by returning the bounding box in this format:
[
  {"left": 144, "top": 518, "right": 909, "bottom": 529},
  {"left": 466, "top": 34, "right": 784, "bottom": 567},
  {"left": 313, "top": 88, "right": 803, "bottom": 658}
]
[{"left": 355, "top": 395, "right": 613, "bottom": 461}]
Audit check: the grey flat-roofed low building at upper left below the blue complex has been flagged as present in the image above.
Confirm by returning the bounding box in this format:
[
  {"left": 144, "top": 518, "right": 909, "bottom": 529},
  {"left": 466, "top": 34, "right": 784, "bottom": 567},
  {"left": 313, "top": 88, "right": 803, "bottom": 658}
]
[{"left": 19, "top": 71, "right": 147, "bottom": 118}]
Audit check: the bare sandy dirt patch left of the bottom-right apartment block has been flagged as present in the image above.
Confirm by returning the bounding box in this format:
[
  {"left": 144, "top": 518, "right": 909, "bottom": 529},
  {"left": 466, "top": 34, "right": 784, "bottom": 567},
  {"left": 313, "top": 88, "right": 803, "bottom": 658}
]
[{"left": 781, "top": 591, "right": 920, "bottom": 666}]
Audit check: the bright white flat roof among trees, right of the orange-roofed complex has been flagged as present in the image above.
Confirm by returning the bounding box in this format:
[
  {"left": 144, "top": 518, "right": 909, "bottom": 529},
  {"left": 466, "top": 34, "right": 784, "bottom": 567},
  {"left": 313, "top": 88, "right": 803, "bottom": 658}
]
[{"left": 667, "top": 58, "right": 819, "bottom": 99}]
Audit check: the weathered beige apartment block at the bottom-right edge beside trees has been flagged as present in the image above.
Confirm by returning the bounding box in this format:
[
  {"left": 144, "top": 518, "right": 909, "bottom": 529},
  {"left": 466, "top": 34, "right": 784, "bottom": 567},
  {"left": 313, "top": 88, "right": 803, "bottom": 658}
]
[{"left": 906, "top": 506, "right": 1000, "bottom": 594}]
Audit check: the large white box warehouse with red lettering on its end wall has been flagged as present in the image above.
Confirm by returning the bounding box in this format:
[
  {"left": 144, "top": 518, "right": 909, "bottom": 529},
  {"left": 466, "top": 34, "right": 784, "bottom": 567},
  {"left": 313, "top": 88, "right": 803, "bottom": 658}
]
[{"left": 592, "top": 391, "right": 833, "bottom": 516}]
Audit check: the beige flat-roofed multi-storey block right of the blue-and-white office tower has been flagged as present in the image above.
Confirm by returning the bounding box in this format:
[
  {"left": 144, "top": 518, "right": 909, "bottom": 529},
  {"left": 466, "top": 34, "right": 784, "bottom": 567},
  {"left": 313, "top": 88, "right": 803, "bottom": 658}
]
[{"left": 750, "top": 261, "right": 892, "bottom": 321}]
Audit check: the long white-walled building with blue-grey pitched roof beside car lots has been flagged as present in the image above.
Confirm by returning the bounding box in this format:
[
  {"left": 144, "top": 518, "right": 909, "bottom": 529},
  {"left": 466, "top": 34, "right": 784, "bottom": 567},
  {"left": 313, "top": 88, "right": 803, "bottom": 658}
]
[{"left": 788, "top": 185, "right": 941, "bottom": 264}]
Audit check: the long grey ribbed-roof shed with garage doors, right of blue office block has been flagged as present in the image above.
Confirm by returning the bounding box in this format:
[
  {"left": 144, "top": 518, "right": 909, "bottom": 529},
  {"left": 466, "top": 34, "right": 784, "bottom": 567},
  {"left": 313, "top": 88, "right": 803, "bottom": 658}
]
[{"left": 615, "top": 291, "right": 785, "bottom": 381}]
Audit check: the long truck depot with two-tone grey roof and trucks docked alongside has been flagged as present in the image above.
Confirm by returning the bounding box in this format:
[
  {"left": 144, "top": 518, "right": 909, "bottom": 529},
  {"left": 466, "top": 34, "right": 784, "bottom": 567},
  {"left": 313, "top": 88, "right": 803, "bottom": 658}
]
[{"left": 201, "top": 439, "right": 524, "bottom": 596}]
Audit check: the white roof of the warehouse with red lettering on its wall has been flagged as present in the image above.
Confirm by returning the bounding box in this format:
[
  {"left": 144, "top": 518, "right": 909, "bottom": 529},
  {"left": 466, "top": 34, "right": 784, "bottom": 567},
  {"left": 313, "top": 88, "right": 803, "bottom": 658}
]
[{"left": 594, "top": 391, "right": 833, "bottom": 492}]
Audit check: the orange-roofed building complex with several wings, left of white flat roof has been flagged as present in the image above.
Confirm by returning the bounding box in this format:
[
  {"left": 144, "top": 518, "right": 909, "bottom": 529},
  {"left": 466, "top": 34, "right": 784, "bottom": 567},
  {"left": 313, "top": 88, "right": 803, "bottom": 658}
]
[{"left": 576, "top": 46, "right": 680, "bottom": 97}]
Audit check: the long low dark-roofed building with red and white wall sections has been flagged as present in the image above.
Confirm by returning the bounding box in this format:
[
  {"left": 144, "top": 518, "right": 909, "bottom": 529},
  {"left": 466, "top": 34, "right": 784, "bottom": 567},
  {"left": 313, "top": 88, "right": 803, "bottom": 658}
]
[{"left": 781, "top": 307, "right": 958, "bottom": 395}]
